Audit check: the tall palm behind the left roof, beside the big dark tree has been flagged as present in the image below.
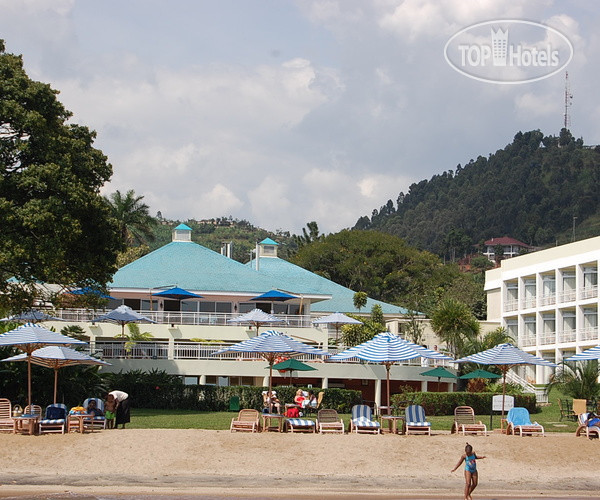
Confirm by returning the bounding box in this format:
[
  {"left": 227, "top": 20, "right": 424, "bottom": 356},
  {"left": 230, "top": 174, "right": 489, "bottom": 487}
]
[{"left": 106, "top": 189, "right": 156, "bottom": 246}]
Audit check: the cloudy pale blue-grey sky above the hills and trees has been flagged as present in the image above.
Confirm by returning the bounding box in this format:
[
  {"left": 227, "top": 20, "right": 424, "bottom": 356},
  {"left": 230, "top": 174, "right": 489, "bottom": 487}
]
[{"left": 0, "top": 0, "right": 600, "bottom": 234}]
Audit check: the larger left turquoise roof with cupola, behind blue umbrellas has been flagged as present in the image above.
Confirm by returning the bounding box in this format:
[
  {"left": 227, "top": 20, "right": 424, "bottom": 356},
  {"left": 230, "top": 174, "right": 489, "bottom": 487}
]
[{"left": 108, "top": 241, "right": 281, "bottom": 294}]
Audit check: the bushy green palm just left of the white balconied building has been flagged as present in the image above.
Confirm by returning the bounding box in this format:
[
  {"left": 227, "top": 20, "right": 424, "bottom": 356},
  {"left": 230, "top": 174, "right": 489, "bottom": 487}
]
[{"left": 431, "top": 299, "right": 480, "bottom": 358}]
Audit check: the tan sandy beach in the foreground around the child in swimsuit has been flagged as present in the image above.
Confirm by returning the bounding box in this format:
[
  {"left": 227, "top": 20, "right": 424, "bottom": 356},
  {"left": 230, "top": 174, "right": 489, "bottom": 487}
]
[{"left": 0, "top": 429, "right": 600, "bottom": 499}]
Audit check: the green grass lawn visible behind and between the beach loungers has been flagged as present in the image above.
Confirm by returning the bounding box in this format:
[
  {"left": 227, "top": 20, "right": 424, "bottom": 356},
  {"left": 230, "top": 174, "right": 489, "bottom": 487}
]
[{"left": 128, "top": 391, "right": 577, "bottom": 432}]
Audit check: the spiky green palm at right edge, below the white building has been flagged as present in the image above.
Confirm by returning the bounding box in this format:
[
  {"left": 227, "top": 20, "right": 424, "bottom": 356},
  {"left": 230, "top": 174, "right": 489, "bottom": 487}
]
[{"left": 546, "top": 360, "right": 600, "bottom": 399}]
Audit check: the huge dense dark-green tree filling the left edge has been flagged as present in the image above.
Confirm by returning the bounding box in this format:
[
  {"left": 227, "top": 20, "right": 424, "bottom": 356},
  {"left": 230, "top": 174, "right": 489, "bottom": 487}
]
[{"left": 0, "top": 40, "right": 121, "bottom": 311}]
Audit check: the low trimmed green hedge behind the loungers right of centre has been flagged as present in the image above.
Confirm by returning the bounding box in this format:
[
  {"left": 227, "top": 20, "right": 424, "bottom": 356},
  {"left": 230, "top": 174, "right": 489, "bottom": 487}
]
[{"left": 391, "top": 392, "right": 539, "bottom": 416}]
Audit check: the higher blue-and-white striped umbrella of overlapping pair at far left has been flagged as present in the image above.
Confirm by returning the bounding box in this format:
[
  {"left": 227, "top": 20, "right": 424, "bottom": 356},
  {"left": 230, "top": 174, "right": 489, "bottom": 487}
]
[{"left": 0, "top": 323, "right": 85, "bottom": 406}]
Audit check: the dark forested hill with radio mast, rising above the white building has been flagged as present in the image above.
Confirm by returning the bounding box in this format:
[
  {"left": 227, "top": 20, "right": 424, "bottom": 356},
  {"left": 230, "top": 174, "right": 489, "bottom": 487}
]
[{"left": 355, "top": 129, "right": 600, "bottom": 255}]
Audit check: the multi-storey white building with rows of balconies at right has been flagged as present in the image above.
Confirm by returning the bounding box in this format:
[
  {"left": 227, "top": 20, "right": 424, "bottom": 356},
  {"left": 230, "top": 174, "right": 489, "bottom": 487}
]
[{"left": 485, "top": 237, "right": 600, "bottom": 384}]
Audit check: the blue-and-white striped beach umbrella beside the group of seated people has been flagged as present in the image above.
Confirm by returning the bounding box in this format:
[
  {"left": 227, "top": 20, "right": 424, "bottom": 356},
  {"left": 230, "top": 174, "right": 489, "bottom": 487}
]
[{"left": 212, "top": 330, "right": 328, "bottom": 406}]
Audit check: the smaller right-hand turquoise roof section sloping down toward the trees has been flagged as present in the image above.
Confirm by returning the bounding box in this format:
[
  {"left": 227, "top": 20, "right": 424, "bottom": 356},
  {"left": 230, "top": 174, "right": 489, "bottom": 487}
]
[{"left": 246, "top": 257, "right": 408, "bottom": 314}]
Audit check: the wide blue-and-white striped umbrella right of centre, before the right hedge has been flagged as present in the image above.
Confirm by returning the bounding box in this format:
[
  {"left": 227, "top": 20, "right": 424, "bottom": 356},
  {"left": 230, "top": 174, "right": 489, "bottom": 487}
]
[{"left": 329, "top": 332, "right": 452, "bottom": 408}]
